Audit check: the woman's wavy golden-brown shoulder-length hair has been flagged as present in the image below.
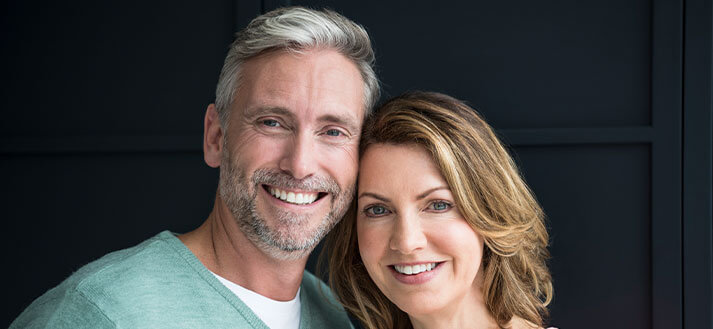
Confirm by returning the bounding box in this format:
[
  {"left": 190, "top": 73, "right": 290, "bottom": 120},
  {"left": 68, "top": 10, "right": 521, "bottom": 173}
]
[{"left": 320, "top": 92, "right": 553, "bottom": 329}]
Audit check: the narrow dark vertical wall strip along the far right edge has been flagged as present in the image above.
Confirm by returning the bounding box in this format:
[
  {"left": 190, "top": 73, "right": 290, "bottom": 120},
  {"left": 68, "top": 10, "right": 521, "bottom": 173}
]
[{"left": 683, "top": 0, "right": 713, "bottom": 328}]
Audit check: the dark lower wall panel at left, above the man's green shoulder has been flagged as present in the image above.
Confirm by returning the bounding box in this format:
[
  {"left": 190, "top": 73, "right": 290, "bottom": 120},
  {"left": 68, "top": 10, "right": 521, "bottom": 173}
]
[{"left": 0, "top": 152, "right": 218, "bottom": 316}]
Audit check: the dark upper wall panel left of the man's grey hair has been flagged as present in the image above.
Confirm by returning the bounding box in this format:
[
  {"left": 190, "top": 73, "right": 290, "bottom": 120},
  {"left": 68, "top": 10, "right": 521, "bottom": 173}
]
[{"left": 0, "top": 1, "right": 235, "bottom": 137}]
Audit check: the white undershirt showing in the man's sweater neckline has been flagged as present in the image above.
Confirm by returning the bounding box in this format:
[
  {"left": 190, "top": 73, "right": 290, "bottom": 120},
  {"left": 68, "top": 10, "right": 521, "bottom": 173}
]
[{"left": 211, "top": 272, "right": 301, "bottom": 329}]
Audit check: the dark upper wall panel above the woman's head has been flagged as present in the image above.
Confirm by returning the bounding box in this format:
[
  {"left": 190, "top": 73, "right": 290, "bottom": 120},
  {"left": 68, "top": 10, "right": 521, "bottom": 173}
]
[{"left": 291, "top": 0, "right": 651, "bottom": 129}]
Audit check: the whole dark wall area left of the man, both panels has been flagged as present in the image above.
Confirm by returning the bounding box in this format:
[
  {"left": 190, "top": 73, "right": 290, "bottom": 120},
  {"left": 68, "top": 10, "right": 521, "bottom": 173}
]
[{"left": 0, "top": 1, "right": 231, "bottom": 327}]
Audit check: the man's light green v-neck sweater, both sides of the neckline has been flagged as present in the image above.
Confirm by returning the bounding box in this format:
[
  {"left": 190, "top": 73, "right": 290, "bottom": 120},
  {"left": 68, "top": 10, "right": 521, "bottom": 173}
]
[{"left": 10, "top": 231, "right": 351, "bottom": 329}]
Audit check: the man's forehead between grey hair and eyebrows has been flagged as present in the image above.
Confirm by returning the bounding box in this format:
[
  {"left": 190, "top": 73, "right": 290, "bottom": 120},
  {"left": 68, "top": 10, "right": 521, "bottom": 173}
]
[{"left": 236, "top": 51, "right": 364, "bottom": 128}]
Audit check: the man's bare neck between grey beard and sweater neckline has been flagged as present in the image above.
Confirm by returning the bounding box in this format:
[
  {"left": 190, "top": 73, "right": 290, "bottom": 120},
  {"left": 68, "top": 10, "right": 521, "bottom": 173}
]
[{"left": 178, "top": 197, "right": 309, "bottom": 301}]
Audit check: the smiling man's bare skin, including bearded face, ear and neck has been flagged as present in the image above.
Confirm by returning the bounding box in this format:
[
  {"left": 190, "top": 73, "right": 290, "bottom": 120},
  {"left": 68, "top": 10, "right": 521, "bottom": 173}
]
[{"left": 179, "top": 50, "right": 364, "bottom": 300}]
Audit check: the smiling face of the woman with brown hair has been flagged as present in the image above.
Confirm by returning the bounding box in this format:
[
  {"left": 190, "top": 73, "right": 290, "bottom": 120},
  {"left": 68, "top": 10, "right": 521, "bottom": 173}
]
[{"left": 357, "top": 144, "right": 483, "bottom": 316}]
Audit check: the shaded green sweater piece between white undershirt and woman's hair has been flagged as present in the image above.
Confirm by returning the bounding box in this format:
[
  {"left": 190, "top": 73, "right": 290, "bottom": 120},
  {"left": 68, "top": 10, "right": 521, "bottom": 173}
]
[{"left": 300, "top": 271, "right": 351, "bottom": 328}]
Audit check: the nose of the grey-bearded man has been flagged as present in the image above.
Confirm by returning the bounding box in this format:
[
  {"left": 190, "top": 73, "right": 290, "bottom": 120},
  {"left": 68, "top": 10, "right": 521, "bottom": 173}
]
[{"left": 280, "top": 134, "right": 319, "bottom": 179}]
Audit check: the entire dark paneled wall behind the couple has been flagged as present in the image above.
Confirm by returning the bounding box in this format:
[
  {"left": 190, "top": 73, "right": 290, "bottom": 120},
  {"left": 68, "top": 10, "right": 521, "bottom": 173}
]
[{"left": 0, "top": 0, "right": 713, "bottom": 329}]
